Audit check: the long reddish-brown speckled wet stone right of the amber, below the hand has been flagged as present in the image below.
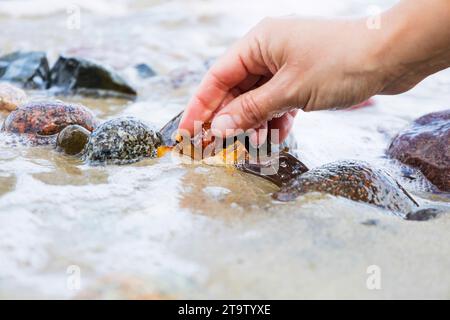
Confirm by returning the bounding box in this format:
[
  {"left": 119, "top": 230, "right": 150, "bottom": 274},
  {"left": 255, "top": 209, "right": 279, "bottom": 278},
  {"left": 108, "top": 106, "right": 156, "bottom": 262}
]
[{"left": 274, "top": 161, "right": 418, "bottom": 214}]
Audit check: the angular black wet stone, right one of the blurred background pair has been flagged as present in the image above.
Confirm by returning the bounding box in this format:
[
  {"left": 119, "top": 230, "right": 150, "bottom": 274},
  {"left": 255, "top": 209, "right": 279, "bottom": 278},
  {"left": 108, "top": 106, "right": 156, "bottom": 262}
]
[{"left": 50, "top": 56, "right": 136, "bottom": 98}]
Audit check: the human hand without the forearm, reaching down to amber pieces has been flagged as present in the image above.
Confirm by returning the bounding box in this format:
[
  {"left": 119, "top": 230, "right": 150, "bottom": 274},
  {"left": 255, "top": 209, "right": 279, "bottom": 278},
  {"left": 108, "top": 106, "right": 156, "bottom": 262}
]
[{"left": 180, "top": 17, "right": 380, "bottom": 143}]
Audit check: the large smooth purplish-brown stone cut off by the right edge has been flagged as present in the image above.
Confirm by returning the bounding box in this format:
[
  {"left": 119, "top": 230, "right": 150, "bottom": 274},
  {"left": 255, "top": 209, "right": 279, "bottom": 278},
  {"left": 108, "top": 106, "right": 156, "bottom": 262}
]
[{"left": 387, "top": 110, "right": 450, "bottom": 192}]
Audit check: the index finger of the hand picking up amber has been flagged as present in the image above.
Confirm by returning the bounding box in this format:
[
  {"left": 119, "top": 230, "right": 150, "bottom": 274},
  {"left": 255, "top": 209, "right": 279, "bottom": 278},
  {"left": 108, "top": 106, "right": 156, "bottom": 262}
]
[{"left": 179, "top": 44, "right": 250, "bottom": 134}]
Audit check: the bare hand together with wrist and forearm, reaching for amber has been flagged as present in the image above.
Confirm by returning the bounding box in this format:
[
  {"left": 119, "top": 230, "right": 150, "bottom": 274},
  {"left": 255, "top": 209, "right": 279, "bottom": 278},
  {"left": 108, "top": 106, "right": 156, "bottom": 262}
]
[{"left": 179, "top": 0, "right": 450, "bottom": 144}]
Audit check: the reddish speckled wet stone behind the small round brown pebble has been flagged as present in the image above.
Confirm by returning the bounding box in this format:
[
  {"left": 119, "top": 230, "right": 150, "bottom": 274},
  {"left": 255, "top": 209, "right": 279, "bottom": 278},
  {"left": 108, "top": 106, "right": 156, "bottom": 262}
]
[{"left": 2, "top": 101, "right": 97, "bottom": 144}]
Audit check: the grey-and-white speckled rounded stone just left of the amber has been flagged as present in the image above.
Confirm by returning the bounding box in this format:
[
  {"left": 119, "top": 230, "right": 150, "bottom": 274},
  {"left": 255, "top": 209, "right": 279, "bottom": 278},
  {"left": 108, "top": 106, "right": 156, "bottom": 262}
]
[{"left": 83, "top": 117, "right": 161, "bottom": 164}]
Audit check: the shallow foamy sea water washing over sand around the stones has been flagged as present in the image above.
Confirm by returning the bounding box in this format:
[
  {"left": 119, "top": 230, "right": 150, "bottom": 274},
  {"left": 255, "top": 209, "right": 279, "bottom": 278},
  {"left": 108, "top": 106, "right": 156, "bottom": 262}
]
[{"left": 0, "top": 0, "right": 450, "bottom": 299}]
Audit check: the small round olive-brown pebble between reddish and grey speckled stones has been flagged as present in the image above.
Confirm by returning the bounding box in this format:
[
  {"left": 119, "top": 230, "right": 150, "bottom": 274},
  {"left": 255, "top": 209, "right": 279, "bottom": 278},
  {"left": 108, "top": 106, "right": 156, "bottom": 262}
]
[{"left": 56, "top": 125, "right": 91, "bottom": 155}]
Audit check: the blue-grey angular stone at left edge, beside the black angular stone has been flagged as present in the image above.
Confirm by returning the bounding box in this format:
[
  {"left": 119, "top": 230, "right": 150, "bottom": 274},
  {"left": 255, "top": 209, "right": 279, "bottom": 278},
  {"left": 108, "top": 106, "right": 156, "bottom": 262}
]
[{"left": 0, "top": 51, "right": 50, "bottom": 89}]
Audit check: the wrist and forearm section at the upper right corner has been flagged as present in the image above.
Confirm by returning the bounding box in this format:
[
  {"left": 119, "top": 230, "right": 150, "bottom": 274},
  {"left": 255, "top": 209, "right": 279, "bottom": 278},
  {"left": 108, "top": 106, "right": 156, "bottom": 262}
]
[{"left": 371, "top": 0, "right": 450, "bottom": 94}]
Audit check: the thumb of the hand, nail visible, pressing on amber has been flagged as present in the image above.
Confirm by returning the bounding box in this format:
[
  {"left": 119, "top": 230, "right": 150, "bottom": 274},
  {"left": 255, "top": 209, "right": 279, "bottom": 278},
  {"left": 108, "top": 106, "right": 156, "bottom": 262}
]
[{"left": 211, "top": 70, "right": 292, "bottom": 136}]
